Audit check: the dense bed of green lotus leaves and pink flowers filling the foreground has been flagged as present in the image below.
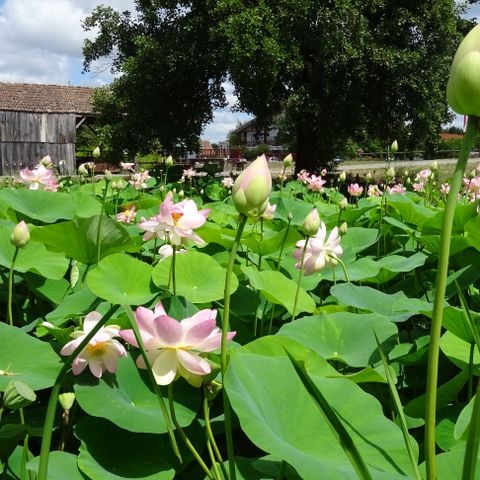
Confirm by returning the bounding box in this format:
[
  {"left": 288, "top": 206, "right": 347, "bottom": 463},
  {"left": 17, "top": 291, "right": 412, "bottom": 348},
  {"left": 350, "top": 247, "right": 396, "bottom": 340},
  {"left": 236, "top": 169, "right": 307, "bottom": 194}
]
[{"left": 0, "top": 158, "right": 480, "bottom": 480}]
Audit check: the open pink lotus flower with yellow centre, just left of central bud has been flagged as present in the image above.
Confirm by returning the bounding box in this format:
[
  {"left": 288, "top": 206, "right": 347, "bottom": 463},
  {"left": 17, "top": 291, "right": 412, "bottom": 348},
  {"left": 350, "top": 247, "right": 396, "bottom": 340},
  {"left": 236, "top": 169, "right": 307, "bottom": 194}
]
[{"left": 138, "top": 192, "right": 210, "bottom": 245}]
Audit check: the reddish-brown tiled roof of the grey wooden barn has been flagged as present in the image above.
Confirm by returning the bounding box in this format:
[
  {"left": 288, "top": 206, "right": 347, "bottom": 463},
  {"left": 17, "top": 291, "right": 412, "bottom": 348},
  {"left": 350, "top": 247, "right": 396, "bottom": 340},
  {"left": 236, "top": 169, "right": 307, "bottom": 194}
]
[{"left": 0, "top": 82, "right": 94, "bottom": 115}]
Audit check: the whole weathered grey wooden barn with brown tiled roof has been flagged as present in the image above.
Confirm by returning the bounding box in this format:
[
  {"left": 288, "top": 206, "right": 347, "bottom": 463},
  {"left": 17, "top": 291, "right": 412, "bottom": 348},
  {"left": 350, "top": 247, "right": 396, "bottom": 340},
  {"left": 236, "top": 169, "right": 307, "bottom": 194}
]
[{"left": 0, "top": 82, "right": 94, "bottom": 175}]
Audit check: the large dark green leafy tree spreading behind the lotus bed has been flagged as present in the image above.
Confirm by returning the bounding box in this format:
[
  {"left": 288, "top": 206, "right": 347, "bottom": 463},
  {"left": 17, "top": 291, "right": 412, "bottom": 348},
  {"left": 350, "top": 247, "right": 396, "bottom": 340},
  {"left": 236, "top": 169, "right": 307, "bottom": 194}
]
[{"left": 85, "top": 0, "right": 468, "bottom": 168}]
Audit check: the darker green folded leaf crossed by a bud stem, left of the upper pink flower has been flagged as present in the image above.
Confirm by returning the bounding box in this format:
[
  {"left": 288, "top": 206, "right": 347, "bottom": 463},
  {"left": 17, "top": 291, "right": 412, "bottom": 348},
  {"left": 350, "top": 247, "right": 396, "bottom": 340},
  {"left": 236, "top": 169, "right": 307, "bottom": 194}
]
[{"left": 32, "top": 216, "right": 137, "bottom": 265}]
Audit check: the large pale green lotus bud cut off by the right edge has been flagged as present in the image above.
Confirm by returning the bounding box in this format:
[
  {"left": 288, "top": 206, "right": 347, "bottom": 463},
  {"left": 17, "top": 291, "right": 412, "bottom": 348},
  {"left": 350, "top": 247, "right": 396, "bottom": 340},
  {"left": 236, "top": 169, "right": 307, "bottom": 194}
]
[{"left": 447, "top": 25, "right": 480, "bottom": 117}]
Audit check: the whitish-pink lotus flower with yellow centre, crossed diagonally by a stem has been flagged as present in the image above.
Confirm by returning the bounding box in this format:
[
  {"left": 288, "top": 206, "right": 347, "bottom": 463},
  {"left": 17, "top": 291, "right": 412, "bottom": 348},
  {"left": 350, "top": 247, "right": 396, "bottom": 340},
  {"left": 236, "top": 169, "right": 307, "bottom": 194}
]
[{"left": 60, "top": 312, "right": 127, "bottom": 378}]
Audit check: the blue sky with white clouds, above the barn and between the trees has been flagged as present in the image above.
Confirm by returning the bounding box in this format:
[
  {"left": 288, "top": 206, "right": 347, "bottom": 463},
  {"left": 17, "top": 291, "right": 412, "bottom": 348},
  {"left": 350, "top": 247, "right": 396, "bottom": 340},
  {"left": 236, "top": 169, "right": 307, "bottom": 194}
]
[{"left": 0, "top": 0, "right": 480, "bottom": 142}]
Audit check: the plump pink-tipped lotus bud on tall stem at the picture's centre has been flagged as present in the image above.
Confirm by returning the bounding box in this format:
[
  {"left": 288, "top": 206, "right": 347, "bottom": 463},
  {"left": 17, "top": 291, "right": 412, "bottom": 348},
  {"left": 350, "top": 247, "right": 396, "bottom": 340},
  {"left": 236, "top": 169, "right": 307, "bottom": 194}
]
[{"left": 232, "top": 155, "right": 272, "bottom": 217}]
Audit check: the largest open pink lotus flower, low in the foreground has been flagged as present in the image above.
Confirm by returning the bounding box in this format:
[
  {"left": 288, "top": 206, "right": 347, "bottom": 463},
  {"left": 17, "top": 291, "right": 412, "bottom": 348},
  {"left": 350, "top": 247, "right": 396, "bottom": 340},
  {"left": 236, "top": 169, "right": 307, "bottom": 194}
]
[{"left": 120, "top": 303, "right": 235, "bottom": 387}]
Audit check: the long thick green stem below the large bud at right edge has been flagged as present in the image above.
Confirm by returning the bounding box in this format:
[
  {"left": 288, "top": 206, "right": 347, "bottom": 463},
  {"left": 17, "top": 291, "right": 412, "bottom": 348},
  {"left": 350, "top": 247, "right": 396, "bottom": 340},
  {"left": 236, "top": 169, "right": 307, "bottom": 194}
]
[{"left": 425, "top": 117, "right": 479, "bottom": 480}]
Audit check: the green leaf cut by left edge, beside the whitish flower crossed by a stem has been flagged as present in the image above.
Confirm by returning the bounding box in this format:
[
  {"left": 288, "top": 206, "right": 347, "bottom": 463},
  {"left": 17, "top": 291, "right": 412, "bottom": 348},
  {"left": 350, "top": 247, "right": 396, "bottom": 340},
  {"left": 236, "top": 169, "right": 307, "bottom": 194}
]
[{"left": 0, "top": 323, "right": 62, "bottom": 391}]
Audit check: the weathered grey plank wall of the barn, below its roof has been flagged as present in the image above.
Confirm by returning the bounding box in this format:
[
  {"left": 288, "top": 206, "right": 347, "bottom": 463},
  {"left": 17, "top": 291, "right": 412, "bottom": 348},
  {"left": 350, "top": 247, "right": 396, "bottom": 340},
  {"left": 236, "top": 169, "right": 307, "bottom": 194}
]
[{"left": 0, "top": 112, "right": 76, "bottom": 175}]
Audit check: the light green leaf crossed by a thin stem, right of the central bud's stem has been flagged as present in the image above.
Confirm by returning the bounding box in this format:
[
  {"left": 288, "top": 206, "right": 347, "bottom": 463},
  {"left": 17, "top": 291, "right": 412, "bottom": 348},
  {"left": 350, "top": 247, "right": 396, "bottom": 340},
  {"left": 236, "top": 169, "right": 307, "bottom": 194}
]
[{"left": 242, "top": 267, "right": 315, "bottom": 314}]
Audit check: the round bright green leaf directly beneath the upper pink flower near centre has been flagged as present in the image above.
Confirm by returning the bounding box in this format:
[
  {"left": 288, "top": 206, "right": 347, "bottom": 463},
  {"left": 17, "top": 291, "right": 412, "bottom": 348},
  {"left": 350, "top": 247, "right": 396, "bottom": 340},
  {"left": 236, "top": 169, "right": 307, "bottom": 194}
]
[{"left": 152, "top": 251, "right": 238, "bottom": 303}]
